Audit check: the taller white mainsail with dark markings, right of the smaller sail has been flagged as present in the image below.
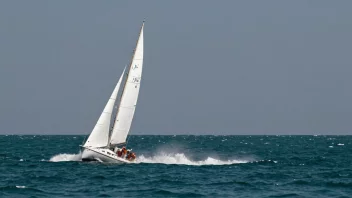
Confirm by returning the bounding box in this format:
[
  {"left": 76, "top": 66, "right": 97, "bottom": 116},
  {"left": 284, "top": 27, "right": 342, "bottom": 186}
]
[{"left": 110, "top": 23, "right": 144, "bottom": 145}]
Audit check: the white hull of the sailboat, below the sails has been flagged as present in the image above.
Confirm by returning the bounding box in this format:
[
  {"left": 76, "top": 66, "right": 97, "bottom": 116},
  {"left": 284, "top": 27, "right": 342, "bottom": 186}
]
[{"left": 82, "top": 147, "right": 132, "bottom": 164}]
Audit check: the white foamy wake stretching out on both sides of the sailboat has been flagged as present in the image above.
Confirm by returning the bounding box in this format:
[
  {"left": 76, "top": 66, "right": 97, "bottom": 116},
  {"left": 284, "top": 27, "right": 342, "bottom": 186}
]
[{"left": 49, "top": 153, "right": 251, "bottom": 166}]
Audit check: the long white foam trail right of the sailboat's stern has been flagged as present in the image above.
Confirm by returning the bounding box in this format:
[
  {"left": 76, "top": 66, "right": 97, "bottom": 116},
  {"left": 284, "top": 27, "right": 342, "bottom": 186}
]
[{"left": 136, "top": 153, "right": 250, "bottom": 166}]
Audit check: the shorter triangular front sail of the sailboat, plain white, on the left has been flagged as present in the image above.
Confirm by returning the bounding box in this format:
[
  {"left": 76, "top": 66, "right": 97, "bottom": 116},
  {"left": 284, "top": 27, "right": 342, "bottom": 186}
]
[{"left": 84, "top": 68, "right": 126, "bottom": 147}]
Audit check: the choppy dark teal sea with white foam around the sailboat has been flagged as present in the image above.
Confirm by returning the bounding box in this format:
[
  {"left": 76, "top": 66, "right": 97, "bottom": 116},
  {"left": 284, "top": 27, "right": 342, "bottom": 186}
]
[{"left": 0, "top": 135, "right": 352, "bottom": 198}]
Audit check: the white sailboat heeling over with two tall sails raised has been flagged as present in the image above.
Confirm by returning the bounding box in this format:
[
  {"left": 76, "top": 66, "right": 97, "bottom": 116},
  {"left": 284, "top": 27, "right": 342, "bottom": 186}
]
[{"left": 81, "top": 21, "right": 144, "bottom": 163}]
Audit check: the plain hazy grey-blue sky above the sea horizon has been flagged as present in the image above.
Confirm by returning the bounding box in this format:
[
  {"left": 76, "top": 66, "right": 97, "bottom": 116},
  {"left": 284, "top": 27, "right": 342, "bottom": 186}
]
[{"left": 0, "top": 0, "right": 352, "bottom": 135}]
